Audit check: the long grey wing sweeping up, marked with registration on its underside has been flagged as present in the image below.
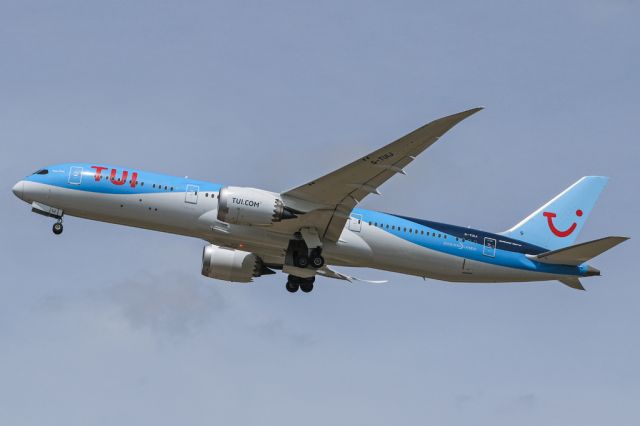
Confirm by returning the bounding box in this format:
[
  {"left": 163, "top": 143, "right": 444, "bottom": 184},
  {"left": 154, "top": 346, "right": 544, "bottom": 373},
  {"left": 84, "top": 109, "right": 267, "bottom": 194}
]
[{"left": 282, "top": 108, "right": 482, "bottom": 241}]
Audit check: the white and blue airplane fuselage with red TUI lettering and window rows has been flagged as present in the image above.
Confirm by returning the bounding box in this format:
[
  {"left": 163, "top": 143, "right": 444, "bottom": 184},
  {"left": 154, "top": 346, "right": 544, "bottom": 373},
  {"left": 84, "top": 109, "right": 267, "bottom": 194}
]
[{"left": 13, "top": 163, "right": 594, "bottom": 282}]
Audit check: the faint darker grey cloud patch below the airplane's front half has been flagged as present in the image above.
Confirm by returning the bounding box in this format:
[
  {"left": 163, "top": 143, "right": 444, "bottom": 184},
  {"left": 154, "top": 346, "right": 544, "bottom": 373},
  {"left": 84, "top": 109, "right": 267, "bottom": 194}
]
[{"left": 36, "top": 271, "right": 315, "bottom": 347}]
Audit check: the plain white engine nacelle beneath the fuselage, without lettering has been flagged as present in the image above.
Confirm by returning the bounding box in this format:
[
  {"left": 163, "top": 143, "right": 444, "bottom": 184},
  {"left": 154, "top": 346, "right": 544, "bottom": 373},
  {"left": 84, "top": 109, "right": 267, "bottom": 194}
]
[{"left": 202, "top": 244, "right": 263, "bottom": 283}]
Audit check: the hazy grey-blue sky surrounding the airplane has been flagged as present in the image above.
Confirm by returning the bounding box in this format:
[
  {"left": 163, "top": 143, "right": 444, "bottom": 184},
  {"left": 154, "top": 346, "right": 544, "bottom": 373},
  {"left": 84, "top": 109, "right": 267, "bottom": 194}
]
[{"left": 0, "top": 0, "right": 640, "bottom": 426}]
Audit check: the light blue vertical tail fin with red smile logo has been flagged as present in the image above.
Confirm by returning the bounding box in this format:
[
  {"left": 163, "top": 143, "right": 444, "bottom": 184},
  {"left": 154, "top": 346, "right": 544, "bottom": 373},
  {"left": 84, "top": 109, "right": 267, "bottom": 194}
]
[{"left": 502, "top": 176, "right": 609, "bottom": 250}]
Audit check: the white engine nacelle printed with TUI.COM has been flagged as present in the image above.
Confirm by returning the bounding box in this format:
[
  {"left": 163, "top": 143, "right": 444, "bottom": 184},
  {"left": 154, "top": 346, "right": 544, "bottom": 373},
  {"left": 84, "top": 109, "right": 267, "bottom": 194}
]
[{"left": 218, "top": 186, "right": 296, "bottom": 226}]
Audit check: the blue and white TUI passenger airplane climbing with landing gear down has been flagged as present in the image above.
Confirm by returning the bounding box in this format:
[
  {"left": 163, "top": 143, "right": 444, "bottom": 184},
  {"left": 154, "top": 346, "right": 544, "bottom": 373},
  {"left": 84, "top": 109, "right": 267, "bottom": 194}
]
[{"left": 13, "top": 108, "right": 628, "bottom": 293}]
